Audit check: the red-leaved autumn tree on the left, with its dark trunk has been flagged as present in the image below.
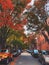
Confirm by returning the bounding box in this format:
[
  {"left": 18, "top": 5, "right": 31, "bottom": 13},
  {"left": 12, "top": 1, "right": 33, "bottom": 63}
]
[{"left": 0, "top": 0, "right": 22, "bottom": 46}]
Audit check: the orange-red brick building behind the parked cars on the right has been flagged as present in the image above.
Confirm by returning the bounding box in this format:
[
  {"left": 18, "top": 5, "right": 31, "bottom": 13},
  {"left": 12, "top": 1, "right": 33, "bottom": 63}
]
[{"left": 36, "top": 34, "right": 49, "bottom": 50}]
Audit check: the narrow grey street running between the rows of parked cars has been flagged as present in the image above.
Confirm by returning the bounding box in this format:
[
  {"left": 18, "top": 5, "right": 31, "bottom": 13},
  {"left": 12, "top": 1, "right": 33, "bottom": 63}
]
[{"left": 10, "top": 52, "right": 41, "bottom": 65}]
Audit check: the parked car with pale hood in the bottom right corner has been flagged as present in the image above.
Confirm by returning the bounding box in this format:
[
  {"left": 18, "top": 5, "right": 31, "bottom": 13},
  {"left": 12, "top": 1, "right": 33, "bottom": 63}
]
[{"left": 39, "top": 50, "right": 49, "bottom": 65}]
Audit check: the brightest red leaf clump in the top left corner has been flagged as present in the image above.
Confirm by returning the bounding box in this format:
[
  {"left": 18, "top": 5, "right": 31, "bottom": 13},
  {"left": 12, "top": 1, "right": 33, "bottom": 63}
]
[{"left": 0, "top": 0, "right": 14, "bottom": 10}]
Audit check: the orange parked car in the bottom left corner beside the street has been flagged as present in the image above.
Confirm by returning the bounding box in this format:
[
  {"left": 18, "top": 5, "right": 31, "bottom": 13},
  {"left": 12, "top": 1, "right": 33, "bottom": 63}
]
[{"left": 0, "top": 49, "right": 13, "bottom": 64}]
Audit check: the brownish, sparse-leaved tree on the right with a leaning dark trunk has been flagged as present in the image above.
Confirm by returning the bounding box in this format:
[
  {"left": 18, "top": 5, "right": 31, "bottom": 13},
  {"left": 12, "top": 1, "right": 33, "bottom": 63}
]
[{"left": 23, "top": 0, "right": 49, "bottom": 43}]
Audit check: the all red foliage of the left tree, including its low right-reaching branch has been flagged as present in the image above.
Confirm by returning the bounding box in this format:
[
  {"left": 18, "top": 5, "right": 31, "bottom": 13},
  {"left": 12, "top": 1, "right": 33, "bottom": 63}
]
[{"left": 0, "top": 0, "right": 27, "bottom": 30}]
